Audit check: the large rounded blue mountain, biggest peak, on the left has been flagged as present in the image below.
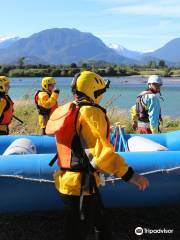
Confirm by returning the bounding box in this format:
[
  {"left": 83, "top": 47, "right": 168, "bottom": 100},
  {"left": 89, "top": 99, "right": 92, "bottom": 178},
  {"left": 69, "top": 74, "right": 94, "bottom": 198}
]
[{"left": 0, "top": 28, "right": 135, "bottom": 64}]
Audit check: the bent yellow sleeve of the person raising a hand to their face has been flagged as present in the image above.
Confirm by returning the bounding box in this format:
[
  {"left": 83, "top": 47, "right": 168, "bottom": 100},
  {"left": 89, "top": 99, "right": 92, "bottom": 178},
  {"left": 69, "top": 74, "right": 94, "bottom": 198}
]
[{"left": 38, "top": 92, "right": 59, "bottom": 109}]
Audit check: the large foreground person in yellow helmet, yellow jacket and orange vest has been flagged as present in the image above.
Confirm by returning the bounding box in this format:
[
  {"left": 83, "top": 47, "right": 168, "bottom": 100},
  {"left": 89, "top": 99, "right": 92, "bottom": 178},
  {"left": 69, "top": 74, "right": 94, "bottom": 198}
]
[{"left": 46, "top": 71, "right": 149, "bottom": 240}]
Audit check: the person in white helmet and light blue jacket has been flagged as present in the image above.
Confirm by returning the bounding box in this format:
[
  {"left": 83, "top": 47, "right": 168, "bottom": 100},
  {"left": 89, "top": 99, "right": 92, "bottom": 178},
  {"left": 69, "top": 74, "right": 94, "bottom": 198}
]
[{"left": 130, "top": 75, "right": 162, "bottom": 133}]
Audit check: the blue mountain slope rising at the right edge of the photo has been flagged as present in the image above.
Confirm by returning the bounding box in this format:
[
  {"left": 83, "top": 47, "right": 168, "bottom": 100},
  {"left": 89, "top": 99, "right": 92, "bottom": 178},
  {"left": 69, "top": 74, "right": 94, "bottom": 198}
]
[{"left": 142, "top": 38, "right": 180, "bottom": 63}]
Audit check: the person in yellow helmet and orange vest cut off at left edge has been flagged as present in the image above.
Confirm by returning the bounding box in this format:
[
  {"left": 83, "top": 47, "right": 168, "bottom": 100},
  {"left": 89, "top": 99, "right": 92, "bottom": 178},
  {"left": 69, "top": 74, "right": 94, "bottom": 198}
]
[{"left": 0, "top": 76, "right": 14, "bottom": 135}]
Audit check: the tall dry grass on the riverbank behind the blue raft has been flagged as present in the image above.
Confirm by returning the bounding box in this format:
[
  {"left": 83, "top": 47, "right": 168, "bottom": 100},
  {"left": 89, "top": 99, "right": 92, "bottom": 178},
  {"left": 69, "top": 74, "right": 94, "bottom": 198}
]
[{"left": 10, "top": 99, "right": 180, "bottom": 135}]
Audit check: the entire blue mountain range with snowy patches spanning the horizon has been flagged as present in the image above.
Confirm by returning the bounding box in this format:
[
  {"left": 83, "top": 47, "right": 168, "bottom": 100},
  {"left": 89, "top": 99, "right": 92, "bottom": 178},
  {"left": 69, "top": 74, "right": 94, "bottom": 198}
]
[{"left": 0, "top": 28, "right": 180, "bottom": 65}]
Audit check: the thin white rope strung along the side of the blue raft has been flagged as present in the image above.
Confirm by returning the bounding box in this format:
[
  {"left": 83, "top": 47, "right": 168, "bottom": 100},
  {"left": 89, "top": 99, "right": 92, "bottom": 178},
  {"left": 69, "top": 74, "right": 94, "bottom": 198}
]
[{"left": 0, "top": 166, "right": 180, "bottom": 183}]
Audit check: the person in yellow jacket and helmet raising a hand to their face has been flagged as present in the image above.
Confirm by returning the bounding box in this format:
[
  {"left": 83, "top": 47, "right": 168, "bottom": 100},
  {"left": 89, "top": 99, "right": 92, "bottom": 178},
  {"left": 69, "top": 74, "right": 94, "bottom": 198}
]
[{"left": 35, "top": 77, "right": 59, "bottom": 135}]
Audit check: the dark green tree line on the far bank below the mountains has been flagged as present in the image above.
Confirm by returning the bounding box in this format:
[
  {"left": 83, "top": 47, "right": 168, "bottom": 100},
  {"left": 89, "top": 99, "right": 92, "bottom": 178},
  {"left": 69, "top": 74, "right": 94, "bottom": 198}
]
[{"left": 0, "top": 58, "right": 177, "bottom": 77}]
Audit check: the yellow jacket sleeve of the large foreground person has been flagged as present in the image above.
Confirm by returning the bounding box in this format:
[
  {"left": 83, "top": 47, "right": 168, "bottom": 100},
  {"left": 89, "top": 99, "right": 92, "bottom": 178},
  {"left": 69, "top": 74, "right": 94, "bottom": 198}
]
[{"left": 79, "top": 107, "right": 133, "bottom": 181}]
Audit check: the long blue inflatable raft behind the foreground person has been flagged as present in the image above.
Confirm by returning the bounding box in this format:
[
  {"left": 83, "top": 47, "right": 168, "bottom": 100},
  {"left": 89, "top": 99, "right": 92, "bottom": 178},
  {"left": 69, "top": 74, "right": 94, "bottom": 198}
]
[{"left": 0, "top": 130, "right": 180, "bottom": 213}]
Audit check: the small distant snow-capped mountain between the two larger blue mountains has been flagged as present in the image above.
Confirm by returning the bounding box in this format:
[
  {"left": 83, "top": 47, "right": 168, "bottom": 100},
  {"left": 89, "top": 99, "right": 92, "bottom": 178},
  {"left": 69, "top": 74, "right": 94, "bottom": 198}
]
[{"left": 109, "top": 43, "right": 142, "bottom": 60}]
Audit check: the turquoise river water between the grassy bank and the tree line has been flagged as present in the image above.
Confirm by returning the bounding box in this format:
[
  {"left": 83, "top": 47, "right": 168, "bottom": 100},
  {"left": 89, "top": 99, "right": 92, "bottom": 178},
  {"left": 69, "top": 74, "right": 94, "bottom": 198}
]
[{"left": 9, "top": 76, "right": 180, "bottom": 117}]
